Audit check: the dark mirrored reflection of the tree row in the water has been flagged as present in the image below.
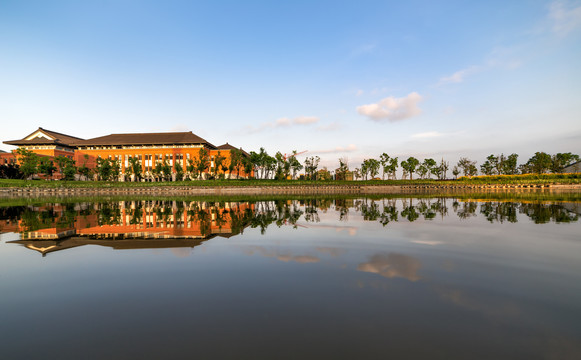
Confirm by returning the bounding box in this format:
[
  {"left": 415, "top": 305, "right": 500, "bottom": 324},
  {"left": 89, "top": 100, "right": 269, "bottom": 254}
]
[{"left": 6, "top": 198, "right": 579, "bottom": 236}]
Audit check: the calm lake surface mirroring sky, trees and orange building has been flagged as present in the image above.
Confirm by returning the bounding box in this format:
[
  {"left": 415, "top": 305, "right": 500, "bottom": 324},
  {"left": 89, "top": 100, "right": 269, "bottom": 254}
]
[{"left": 0, "top": 198, "right": 581, "bottom": 359}]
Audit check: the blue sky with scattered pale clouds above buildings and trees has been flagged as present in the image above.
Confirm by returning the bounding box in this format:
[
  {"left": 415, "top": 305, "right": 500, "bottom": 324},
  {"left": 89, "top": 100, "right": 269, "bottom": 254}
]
[{"left": 0, "top": 0, "right": 581, "bottom": 169}]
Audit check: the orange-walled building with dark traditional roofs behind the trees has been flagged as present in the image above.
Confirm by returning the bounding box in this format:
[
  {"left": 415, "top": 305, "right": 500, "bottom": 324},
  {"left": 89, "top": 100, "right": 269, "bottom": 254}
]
[{"left": 0, "top": 128, "right": 252, "bottom": 181}]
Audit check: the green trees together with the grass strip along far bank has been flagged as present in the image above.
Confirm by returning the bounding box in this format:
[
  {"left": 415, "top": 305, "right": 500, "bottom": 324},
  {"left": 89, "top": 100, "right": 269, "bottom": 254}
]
[{"left": 0, "top": 148, "right": 579, "bottom": 187}]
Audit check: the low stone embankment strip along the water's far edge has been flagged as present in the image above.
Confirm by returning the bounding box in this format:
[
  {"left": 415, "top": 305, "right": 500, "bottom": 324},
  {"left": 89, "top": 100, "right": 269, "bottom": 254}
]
[{"left": 0, "top": 184, "right": 581, "bottom": 198}]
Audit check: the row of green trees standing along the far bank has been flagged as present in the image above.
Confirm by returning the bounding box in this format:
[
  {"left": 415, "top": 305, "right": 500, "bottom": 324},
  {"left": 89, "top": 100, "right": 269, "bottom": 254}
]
[{"left": 0, "top": 148, "right": 579, "bottom": 181}]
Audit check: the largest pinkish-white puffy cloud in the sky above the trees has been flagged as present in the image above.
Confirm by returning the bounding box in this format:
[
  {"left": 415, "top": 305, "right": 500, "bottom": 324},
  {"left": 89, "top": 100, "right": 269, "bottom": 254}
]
[{"left": 357, "top": 92, "right": 422, "bottom": 121}]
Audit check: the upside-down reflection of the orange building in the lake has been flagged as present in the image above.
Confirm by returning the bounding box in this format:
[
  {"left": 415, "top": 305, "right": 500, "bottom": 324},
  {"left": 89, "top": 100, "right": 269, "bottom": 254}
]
[{"left": 0, "top": 201, "right": 254, "bottom": 255}]
